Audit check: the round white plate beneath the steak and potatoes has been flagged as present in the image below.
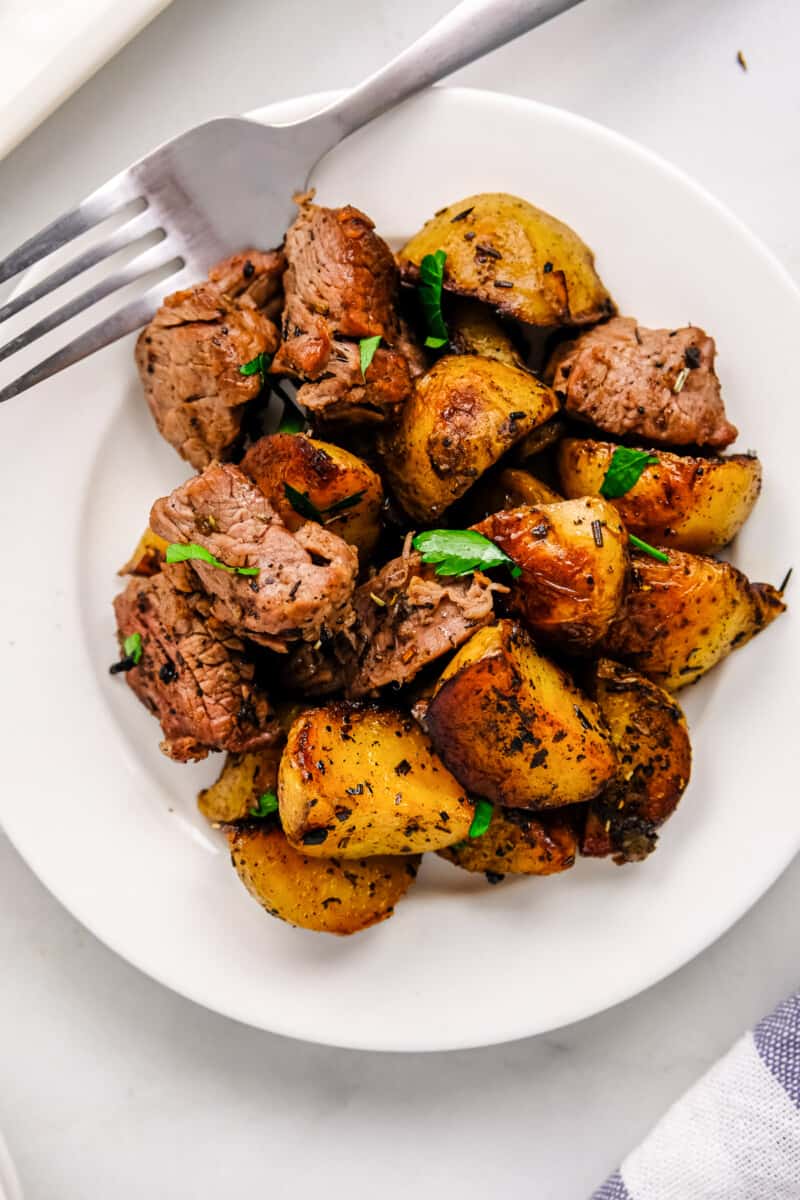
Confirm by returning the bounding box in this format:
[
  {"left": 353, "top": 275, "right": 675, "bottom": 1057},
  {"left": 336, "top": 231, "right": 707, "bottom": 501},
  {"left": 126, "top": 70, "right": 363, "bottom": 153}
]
[{"left": 0, "top": 89, "right": 800, "bottom": 1050}]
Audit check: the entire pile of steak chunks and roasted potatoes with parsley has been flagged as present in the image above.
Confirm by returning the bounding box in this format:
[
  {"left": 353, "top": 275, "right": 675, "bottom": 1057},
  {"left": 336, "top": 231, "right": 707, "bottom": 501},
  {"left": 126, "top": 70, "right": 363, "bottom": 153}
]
[{"left": 112, "top": 194, "right": 784, "bottom": 934}]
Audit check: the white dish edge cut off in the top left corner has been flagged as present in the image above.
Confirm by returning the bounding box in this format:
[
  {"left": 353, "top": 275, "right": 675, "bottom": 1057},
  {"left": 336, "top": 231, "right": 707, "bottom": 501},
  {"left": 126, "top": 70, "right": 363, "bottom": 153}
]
[{"left": 0, "top": 0, "right": 169, "bottom": 158}]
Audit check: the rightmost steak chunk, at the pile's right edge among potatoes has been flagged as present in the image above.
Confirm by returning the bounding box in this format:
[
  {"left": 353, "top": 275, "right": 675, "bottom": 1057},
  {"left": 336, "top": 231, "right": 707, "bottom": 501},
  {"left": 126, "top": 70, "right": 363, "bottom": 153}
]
[{"left": 547, "top": 317, "right": 738, "bottom": 449}]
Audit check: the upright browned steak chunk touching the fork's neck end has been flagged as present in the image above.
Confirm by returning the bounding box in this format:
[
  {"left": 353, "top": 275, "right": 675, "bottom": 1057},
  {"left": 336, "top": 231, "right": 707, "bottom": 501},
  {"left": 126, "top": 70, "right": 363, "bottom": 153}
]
[{"left": 272, "top": 202, "right": 425, "bottom": 424}]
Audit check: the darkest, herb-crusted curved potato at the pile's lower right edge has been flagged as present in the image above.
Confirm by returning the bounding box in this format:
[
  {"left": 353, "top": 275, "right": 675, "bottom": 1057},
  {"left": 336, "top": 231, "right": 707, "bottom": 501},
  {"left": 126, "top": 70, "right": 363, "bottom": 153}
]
[{"left": 581, "top": 659, "right": 692, "bottom": 864}]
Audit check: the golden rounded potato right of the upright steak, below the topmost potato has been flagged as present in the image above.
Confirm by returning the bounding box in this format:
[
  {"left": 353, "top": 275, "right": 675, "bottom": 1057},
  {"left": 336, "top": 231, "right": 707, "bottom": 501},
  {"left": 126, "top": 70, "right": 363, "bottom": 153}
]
[{"left": 381, "top": 354, "right": 558, "bottom": 522}]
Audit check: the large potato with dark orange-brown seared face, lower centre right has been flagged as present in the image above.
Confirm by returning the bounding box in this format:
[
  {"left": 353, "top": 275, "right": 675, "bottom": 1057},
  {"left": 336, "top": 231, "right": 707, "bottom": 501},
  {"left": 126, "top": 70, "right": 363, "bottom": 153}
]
[{"left": 425, "top": 620, "right": 616, "bottom": 809}]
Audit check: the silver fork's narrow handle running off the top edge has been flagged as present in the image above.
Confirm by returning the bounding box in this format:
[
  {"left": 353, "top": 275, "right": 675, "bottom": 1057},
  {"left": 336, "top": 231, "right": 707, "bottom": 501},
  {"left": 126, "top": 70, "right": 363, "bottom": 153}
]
[{"left": 303, "top": 0, "right": 581, "bottom": 152}]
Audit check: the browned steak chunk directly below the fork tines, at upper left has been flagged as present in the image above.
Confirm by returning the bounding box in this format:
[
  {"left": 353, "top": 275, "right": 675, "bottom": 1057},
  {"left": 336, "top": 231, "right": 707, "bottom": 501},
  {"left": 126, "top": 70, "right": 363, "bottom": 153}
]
[{"left": 136, "top": 250, "right": 285, "bottom": 470}]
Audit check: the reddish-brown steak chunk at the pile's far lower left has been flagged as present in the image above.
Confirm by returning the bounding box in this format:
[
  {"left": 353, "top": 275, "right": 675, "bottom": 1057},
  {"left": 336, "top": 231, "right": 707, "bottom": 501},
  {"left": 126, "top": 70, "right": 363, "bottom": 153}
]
[{"left": 114, "top": 564, "right": 281, "bottom": 762}]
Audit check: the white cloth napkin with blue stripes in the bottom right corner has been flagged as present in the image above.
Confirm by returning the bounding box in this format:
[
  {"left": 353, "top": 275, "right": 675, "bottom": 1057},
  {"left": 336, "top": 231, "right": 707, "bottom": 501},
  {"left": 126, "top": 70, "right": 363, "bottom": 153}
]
[{"left": 593, "top": 992, "right": 800, "bottom": 1200}]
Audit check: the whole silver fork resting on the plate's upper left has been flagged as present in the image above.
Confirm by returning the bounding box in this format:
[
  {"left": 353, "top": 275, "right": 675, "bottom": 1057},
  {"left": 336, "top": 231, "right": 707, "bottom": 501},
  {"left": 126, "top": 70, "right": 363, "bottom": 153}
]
[{"left": 0, "top": 0, "right": 579, "bottom": 402}]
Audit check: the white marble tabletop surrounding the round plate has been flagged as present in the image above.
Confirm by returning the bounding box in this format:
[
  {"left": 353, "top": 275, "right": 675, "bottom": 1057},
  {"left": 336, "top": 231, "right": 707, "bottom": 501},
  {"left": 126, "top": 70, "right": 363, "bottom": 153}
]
[{"left": 0, "top": 0, "right": 800, "bottom": 1200}]
